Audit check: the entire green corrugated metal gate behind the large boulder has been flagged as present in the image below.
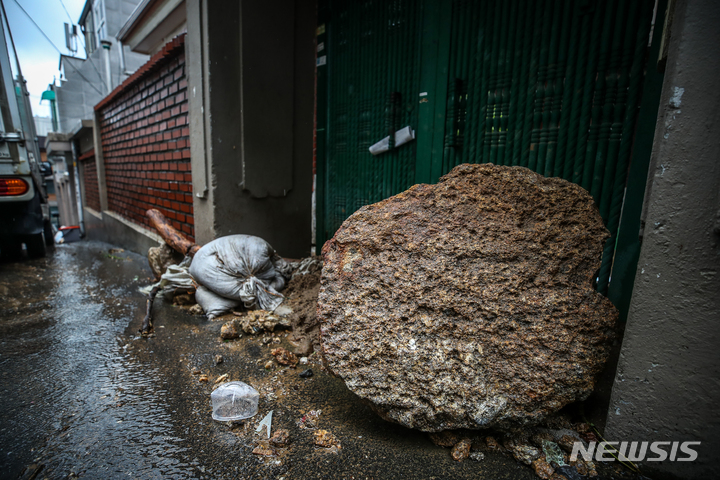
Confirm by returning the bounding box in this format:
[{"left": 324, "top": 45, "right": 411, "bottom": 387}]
[{"left": 317, "top": 0, "right": 660, "bottom": 312}]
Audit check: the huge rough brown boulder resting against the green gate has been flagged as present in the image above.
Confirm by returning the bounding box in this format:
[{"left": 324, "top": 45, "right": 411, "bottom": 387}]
[{"left": 318, "top": 164, "right": 617, "bottom": 431}]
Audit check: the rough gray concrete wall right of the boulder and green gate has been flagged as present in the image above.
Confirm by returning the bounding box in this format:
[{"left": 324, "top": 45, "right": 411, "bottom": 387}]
[{"left": 605, "top": 0, "right": 720, "bottom": 478}]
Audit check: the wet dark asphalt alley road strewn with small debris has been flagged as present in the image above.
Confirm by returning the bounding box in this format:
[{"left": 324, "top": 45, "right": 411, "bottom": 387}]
[{"left": 0, "top": 242, "right": 624, "bottom": 480}]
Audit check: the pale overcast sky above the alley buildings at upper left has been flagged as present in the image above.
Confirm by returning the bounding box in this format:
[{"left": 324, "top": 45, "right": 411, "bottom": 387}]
[{"left": 0, "top": 0, "right": 85, "bottom": 117}]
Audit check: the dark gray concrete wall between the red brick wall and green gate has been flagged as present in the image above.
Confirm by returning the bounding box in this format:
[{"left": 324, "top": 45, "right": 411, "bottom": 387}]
[{"left": 186, "top": 0, "right": 316, "bottom": 258}]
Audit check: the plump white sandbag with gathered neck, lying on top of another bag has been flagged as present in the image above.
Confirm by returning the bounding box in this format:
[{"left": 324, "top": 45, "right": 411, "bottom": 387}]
[{"left": 190, "top": 235, "right": 292, "bottom": 311}]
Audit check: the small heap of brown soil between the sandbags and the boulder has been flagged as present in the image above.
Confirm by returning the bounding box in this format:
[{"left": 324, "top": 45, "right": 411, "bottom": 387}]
[{"left": 282, "top": 270, "right": 320, "bottom": 355}]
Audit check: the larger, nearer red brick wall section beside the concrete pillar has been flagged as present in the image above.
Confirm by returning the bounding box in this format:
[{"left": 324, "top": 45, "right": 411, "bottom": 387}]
[{"left": 95, "top": 35, "right": 194, "bottom": 239}]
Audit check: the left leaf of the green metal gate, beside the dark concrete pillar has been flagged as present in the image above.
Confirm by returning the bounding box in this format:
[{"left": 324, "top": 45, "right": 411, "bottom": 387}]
[{"left": 318, "top": 0, "right": 421, "bottom": 242}]
